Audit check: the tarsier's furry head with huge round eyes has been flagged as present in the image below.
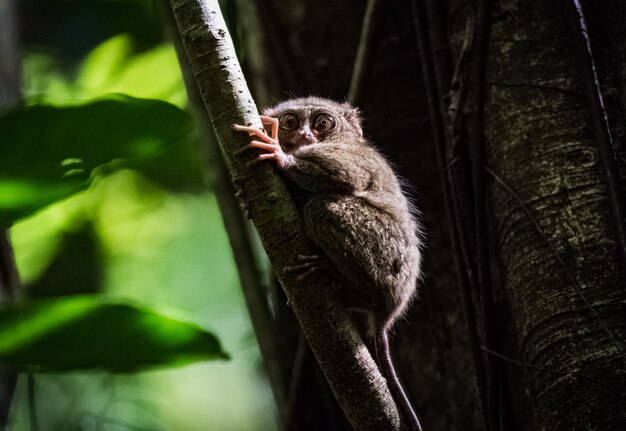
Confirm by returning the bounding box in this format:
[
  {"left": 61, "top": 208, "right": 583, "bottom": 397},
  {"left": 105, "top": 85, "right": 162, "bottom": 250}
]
[{"left": 263, "top": 97, "right": 363, "bottom": 152}]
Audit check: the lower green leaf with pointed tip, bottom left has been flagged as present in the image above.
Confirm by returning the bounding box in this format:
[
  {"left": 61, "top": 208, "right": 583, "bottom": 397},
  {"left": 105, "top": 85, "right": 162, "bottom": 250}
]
[{"left": 0, "top": 295, "right": 229, "bottom": 372}]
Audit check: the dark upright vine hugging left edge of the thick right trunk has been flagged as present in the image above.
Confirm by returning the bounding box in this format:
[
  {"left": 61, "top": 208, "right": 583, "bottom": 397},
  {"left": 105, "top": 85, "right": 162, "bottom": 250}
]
[{"left": 448, "top": 1, "right": 503, "bottom": 431}]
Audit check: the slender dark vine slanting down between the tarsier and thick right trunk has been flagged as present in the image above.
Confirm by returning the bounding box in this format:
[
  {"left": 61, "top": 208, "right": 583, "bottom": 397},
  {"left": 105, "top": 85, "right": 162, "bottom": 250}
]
[{"left": 412, "top": 0, "right": 498, "bottom": 427}]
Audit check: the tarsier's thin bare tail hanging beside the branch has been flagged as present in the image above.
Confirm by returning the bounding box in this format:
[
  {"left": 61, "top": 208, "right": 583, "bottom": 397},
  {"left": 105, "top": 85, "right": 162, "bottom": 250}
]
[{"left": 375, "top": 331, "right": 422, "bottom": 431}]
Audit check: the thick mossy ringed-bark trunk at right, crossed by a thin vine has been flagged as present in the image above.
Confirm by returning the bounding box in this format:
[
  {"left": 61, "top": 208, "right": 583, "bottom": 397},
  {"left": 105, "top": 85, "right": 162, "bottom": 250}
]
[{"left": 485, "top": 1, "right": 626, "bottom": 429}]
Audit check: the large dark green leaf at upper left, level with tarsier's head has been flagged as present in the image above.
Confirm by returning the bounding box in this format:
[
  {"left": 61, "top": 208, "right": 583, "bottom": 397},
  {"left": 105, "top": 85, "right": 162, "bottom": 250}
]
[{"left": 0, "top": 95, "right": 201, "bottom": 224}]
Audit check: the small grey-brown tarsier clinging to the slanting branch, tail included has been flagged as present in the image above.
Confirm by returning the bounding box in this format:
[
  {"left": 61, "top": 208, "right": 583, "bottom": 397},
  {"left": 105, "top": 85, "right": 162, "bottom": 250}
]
[{"left": 233, "top": 97, "right": 421, "bottom": 430}]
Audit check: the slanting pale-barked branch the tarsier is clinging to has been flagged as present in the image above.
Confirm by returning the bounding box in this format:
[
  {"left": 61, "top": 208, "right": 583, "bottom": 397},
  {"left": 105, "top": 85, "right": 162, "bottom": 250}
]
[{"left": 166, "top": 0, "right": 400, "bottom": 430}]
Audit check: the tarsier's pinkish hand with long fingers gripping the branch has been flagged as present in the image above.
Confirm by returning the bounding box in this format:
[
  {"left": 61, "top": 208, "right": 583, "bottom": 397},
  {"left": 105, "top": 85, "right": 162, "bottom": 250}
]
[{"left": 233, "top": 115, "right": 294, "bottom": 169}]
